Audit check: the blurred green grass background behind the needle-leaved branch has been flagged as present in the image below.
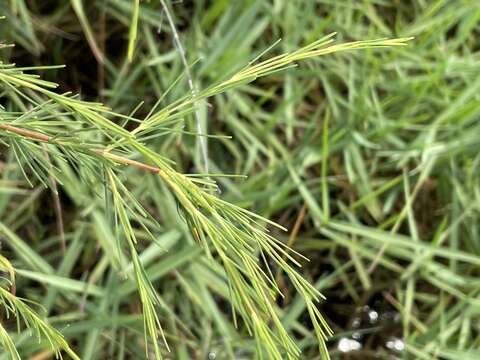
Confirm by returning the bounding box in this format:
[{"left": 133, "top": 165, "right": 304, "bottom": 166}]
[{"left": 0, "top": 0, "right": 480, "bottom": 360}]
